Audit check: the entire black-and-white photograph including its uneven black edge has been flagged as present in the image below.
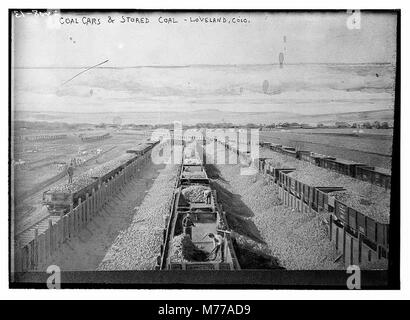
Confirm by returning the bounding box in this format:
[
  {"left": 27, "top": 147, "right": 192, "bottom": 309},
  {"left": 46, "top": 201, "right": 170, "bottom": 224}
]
[{"left": 9, "top": 9, "right": 405, "bottom": 290}]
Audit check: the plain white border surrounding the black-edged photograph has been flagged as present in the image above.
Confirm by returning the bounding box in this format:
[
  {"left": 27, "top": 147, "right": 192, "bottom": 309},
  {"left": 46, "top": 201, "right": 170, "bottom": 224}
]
[{"left": 0, "top": 0, "right": 410, "bottom": 300}]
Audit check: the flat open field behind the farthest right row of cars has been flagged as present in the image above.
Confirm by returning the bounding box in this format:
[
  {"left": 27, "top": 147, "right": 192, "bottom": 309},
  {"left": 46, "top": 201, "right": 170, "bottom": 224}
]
[{"left": 259, "top": 129, "right": 393, "bottom": 169}]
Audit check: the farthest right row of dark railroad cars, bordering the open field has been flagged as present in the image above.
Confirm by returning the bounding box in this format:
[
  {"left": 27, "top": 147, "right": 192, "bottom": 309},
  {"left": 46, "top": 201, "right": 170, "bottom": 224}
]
[{"left": 260, "top": 142, "right": 391, "bottom": 189}]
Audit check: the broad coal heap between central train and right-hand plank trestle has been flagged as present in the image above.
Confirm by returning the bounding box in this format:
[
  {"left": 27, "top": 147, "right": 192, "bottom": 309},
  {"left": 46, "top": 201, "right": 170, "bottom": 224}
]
[{"left": 211, "top": 160, "right": 343, "bottom": 270}]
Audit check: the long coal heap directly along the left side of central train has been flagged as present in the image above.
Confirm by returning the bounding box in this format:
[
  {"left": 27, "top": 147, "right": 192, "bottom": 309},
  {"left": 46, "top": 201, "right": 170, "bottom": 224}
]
[{"left": 97, "top": 164, "right": 177, "bottom": 270}]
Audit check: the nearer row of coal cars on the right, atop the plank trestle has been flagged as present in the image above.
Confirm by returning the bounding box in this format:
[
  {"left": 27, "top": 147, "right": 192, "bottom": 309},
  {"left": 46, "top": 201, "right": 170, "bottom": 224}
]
[{"left": 258, "top": 158, "right": 390, "bottom": 258}]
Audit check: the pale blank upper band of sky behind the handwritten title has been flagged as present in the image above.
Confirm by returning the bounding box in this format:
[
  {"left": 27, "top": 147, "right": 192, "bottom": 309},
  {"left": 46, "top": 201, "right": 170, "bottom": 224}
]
[{"left": 12, "top": 12, "right": 396, "bottom": 67}]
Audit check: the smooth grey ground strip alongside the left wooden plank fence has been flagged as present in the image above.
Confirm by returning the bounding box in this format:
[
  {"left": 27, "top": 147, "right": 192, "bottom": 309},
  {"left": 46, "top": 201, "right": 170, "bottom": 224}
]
[{"left": 38, "top": 162, "right": 163, "bottom": 271}]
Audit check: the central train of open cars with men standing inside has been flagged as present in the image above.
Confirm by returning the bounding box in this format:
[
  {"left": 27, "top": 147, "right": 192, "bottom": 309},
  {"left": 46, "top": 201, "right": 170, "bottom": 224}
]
[{"left": 160, "top": 143, "right": 240, "bottom": 270}]
